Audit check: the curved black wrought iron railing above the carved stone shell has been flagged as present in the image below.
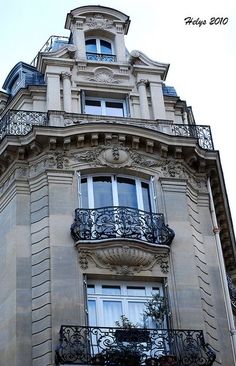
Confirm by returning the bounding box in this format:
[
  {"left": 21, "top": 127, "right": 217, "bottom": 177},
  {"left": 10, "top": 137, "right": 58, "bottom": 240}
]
[{"left": 71, "top": 206, "right": 175, "bottom": 245}]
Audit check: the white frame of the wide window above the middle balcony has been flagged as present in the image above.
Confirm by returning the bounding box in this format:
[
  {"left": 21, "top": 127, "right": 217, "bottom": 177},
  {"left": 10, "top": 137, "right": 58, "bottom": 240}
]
[{"left": 81, "top": 173, "right": 155, "bottom": 212}]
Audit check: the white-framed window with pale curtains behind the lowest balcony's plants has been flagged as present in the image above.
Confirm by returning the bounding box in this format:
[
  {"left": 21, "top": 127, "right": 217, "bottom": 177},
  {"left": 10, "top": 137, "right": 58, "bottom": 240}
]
[{"left": 87, "top": 281, "right": 163, "bottom": 327}]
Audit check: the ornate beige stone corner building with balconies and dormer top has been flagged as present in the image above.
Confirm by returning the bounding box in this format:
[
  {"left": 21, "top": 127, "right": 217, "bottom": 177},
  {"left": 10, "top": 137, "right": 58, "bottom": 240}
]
[{"left": 0, "top": 6, "right": 236, "bottom": 366}]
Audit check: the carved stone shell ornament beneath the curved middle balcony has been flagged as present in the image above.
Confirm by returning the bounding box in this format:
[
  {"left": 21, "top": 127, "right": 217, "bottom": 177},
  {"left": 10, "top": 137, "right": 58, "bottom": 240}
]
[{"left": 78, "top": 242, "right": 169, "bottom": 275}]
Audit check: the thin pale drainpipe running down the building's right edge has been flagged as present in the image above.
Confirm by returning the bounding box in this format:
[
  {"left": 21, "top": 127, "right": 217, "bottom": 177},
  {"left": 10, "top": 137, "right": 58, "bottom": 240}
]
[{"left": 207, "top": 178, "right": 236, "bottom": 365}]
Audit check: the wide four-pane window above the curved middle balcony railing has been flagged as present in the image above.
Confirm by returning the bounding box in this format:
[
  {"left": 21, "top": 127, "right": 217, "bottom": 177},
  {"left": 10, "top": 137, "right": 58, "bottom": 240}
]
[{"left": 80, "top": 175, "right": 152, "bottom": 212}]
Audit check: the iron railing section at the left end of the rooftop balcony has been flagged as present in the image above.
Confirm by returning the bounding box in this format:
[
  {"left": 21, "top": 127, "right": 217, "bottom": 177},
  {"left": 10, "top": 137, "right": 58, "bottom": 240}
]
[{"left": 0, "top": 110, "right": 48, "bottom": 139}]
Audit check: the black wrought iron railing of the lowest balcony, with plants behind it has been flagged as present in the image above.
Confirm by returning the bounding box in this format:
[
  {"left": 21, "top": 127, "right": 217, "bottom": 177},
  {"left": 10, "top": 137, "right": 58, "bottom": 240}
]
[{"left": 55, "top": 325, "right": 215, "bottom": 366}]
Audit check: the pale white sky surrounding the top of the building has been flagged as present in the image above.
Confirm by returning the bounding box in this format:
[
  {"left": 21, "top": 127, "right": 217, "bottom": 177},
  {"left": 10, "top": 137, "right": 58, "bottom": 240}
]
[{"left": 0, "top": 0, "right": 236, "bottom": 229}]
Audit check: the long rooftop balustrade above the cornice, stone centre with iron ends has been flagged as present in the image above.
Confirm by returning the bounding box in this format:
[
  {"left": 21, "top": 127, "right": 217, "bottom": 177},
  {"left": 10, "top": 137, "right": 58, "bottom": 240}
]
[{"left": 0, "top": 110, "right": 214, "bottom": 150}]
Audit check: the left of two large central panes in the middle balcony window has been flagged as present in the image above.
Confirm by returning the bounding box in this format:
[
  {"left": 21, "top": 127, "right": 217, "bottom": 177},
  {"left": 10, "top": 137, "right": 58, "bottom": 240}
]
[{"left": 93, "top": 177, "right": 113, "bottom": 208}]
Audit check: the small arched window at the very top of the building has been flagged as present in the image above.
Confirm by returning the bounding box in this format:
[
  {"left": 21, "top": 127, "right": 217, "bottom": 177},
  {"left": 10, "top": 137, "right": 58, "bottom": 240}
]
[{"left": 85, "top": 38, "right": 116, "bottom": 62}]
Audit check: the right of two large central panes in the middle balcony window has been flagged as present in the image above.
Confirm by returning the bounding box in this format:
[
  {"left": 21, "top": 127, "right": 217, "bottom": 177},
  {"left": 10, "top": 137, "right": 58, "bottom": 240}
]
[{"left": 117, "top": 177, "right": 138, "bottom": 208}]
